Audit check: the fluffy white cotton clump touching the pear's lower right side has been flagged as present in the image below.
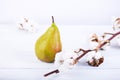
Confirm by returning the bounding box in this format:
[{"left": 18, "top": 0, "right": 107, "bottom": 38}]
[{"left": 54, "top": 51, "right": 78, "bottom": 72}]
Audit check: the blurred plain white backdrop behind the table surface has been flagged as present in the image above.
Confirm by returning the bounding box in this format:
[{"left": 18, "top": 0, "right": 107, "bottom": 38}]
[{"left": 0, "top": 0, "right": 120, "bottom": 25}]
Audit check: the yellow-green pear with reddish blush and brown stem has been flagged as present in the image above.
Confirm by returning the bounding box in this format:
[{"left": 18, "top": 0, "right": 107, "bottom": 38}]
[{"left": 35, "top": 16, "right": 62, "bottom": 62}]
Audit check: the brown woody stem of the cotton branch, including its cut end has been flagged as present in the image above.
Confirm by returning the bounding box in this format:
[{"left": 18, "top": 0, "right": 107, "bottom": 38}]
[{"left": 44, "top": 32, "right": 120, "bottom": 77}]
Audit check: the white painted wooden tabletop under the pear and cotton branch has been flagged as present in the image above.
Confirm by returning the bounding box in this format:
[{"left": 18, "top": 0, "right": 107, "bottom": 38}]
[{"left": 0, "top": 24, "right": 120, "bottom": 80}]
